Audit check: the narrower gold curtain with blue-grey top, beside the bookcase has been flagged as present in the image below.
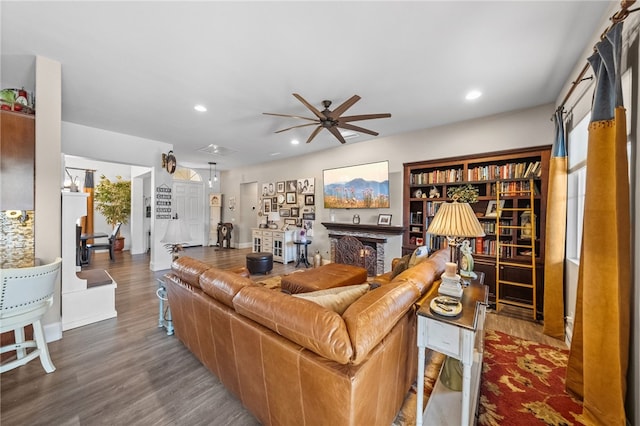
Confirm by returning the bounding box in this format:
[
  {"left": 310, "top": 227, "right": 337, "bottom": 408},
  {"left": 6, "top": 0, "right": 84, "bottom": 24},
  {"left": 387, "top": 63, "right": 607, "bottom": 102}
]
[{"left": 543, "top": 109, "right": 567, "bottom": 339}]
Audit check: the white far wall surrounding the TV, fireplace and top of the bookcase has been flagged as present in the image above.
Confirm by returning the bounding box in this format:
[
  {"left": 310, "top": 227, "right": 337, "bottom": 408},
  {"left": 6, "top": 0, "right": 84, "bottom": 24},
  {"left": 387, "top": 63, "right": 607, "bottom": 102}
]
[{"left": 222, "top": 104, "right": 554, "bottom": 257}]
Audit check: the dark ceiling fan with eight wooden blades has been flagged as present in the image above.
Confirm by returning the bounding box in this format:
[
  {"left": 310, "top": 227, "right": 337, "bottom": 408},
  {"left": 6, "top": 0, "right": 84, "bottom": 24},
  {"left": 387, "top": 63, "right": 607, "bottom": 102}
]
[{"left": 263, "top": 93, "right": 391, "bottom": 143}]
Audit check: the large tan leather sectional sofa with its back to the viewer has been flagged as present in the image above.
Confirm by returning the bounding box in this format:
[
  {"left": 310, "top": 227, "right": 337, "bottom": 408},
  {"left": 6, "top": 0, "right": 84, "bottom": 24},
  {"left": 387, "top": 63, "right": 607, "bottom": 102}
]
[{"left": 165, "top": 250, "right": 448, "bottom": 426}]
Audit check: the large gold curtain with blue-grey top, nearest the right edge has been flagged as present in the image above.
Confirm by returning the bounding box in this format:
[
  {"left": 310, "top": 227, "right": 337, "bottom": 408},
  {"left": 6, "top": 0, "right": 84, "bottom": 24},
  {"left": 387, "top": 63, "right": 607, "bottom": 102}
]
[{"left": 566, "top": 23, "right": 631, "bottom": 426}]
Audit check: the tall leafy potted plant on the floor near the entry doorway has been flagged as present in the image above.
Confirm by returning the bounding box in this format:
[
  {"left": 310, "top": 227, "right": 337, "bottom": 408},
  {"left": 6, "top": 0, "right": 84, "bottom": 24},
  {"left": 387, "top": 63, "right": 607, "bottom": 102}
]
[{"left": 95, "top": 175, "right": 131, "bottom": 250}]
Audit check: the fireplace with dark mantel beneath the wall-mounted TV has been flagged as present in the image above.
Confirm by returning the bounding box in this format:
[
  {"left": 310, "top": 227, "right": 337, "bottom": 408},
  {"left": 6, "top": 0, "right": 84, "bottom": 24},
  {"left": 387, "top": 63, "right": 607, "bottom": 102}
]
[{"left": 322, "top": 222, "right": 404, "bottom": 276}]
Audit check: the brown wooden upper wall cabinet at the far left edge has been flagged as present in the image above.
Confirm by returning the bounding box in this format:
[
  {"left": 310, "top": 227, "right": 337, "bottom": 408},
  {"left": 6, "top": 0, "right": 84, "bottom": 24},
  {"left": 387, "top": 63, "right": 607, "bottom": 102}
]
[{"left": 0, "top": 110, "right": 36, "bottom": 210}]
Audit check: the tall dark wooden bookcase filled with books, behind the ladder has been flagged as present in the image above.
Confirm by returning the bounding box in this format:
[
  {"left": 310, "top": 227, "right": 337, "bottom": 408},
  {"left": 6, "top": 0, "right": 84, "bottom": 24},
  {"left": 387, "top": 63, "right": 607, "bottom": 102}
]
[{"left": 402, "top": 146, "right": 551, "bottom": 317}]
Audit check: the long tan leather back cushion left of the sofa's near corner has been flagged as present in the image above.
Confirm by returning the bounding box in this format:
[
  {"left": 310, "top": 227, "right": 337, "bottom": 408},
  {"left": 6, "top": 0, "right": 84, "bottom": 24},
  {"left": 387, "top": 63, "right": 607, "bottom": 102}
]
[{"left": 233, "top": 286, "right": 353, "bottom": 364}]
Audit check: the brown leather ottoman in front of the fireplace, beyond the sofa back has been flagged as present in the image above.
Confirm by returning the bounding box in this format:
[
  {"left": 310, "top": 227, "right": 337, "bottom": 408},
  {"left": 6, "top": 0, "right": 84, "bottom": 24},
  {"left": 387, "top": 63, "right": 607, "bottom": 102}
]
[{"left": 282, "top": 263, "right": 367, "bottom": 294}]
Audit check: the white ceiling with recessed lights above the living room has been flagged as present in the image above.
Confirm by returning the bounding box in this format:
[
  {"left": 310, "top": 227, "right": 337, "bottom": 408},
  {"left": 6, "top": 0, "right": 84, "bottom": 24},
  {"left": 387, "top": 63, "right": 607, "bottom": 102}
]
[{"left": 0, "top": 0, "right": 613, "bottom": 170}]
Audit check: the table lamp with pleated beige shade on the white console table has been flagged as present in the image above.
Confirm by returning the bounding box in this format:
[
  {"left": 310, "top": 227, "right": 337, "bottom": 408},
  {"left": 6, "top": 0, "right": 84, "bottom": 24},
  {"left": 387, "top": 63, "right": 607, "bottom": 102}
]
[{"left": 427, "top": 200, "right": 485, "bottom": 298}]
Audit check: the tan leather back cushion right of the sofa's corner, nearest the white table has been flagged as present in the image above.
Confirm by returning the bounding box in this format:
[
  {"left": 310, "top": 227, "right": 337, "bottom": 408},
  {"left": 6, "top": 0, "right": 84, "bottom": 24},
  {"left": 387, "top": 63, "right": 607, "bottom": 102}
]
[{"left": 342, "top": 282, "right": 420, "bottom": 364}]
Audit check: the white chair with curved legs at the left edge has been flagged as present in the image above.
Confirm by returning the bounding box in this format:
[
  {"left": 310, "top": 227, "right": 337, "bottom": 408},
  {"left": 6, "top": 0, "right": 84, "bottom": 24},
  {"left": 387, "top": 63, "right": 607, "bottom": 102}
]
[{"left": 0, "top": 258, "right": 62, "bottom": 373}]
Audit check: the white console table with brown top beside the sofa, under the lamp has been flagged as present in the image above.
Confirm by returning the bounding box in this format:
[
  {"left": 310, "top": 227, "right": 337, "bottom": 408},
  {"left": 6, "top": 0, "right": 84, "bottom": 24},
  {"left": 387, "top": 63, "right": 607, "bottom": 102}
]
[{"left": 416, "top": 283, "right": 489, "bottom": 426}]
